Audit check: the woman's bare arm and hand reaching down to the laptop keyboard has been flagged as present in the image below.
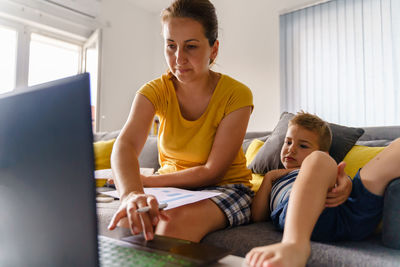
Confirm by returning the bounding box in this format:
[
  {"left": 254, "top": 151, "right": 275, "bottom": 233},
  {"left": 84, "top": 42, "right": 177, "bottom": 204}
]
[{"left": 108, "top": 94, "right": 168, "bottom": 239}]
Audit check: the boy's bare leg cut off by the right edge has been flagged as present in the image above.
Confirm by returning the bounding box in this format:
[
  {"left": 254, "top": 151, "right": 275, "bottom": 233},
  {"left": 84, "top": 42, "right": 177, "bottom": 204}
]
[{"left": 360, "top": 138, "right": 400, "bottom": 196}]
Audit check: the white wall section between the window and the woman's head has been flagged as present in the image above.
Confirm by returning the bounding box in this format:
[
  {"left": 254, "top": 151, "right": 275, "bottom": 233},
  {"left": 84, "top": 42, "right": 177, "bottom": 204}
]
[{"left": 99, "top": 0, "right": 162, "bottom": 131}]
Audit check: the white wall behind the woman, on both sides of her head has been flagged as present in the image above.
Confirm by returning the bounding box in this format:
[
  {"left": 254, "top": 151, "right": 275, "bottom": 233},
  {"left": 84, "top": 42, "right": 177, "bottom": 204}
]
[{"left": 100, "top": 0, "right": 317, "bottom": 131}]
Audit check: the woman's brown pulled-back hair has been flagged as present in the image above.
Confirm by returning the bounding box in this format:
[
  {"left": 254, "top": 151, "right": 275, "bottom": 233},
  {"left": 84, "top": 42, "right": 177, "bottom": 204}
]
[{"left": 161, "top": 0, "right": 218, "bottom": 46}]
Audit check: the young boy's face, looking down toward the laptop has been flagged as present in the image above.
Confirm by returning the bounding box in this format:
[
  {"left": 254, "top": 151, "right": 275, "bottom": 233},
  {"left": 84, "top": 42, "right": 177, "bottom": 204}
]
[{"left": 281, "top": 124, "right": 319, "bottom": 169}]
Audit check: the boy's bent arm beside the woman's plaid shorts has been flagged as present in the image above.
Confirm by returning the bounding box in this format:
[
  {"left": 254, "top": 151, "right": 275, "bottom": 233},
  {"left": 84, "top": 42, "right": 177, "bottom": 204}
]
[{"left": 251, "top": 169, "right": 294, "bottom": 222}]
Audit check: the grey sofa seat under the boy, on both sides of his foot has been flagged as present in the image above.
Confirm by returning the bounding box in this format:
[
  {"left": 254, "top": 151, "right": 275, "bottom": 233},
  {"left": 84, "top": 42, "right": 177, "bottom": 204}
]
[{"left": 201, "top": 222, "right": 400, "bottom": 267}]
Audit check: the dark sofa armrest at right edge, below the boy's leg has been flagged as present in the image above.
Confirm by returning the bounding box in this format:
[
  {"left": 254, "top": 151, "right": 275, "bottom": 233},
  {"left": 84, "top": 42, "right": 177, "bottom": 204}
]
[{"left": 382, "top": 178, "right": 400, "bottom": 249}]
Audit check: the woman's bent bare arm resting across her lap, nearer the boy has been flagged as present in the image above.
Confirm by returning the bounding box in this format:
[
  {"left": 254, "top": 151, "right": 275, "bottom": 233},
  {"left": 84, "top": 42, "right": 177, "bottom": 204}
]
[{"left": 142, "top": 106, "right": 251, "bottom": 188}]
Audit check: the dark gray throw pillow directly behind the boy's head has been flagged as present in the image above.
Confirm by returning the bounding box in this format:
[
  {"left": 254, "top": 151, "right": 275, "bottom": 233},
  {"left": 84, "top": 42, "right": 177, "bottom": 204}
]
[{"left": 248, "top": 112, "right": 364, "bottom": 174}]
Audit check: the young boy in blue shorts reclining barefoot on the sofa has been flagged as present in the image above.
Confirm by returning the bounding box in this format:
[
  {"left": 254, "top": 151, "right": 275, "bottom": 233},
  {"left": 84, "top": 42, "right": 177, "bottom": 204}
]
[{"left": 246, "top": 112, "right": 400, "bottom": 267}]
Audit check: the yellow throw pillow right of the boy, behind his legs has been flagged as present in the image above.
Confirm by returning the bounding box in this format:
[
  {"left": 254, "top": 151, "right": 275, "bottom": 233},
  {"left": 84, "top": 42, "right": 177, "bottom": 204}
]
[{"left": 343, "top": 145, "right": 385, "bottom": 178}]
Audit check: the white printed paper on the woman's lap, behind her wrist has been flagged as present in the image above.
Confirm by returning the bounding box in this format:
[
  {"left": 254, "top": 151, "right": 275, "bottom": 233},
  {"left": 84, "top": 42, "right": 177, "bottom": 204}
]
[{"left": 102, "top": 187, "right": 221, "bottom": 210}]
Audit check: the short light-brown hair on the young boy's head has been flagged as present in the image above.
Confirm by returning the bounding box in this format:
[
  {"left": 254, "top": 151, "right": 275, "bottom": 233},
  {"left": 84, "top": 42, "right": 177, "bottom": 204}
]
[{"left": 289, "top": 111, "right": 332, "bottom": 152}]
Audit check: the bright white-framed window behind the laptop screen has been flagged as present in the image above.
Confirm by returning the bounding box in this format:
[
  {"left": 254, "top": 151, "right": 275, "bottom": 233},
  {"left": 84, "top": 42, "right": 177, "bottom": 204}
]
[{"left": 0, "top": 15, "right": 100, "bottom": 131}]
